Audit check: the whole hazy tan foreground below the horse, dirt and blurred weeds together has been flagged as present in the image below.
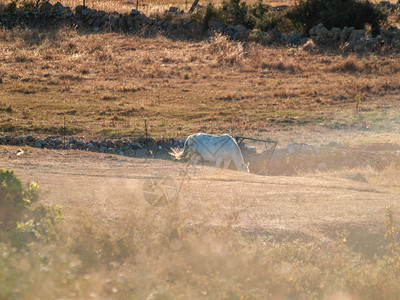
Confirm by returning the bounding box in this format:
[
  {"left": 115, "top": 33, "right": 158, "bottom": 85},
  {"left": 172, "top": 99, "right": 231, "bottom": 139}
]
[{"left": 0, "top": 146, "right": 400, "bottom": 299}]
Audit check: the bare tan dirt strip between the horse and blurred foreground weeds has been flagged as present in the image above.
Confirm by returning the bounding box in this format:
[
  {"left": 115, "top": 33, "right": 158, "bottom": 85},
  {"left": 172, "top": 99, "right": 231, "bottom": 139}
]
[{"left": 0, "top": 146, "right": 399, "bottom": 255}]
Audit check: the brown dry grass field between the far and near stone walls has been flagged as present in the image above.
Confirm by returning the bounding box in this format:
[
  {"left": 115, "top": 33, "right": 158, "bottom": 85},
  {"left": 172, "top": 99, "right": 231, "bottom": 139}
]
[{"left": 0, "top": 28, "right": 400, "bottom": 145}]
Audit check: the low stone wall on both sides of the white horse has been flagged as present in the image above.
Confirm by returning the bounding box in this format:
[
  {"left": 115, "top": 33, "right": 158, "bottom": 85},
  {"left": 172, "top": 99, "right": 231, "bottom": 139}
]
[{"left": 0, "top": 136, "right": 400, "bottom": 175}]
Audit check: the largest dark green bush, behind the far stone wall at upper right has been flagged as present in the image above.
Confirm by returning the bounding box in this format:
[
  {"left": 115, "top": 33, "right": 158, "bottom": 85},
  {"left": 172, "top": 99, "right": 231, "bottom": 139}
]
[{"left": 287, "top": 0, "right": 388, "bottom": 36}]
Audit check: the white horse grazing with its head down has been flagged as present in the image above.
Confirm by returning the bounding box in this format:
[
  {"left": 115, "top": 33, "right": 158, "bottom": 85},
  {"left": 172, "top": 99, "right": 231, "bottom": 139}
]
[{"left": 173, "top": 133, "right": 249, "bottom": 172}]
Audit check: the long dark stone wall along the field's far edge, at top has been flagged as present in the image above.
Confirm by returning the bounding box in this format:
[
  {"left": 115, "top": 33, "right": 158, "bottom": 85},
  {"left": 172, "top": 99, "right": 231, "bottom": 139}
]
[{"left": 0, "top": 2, "right": 400, "bottom": 51}]
